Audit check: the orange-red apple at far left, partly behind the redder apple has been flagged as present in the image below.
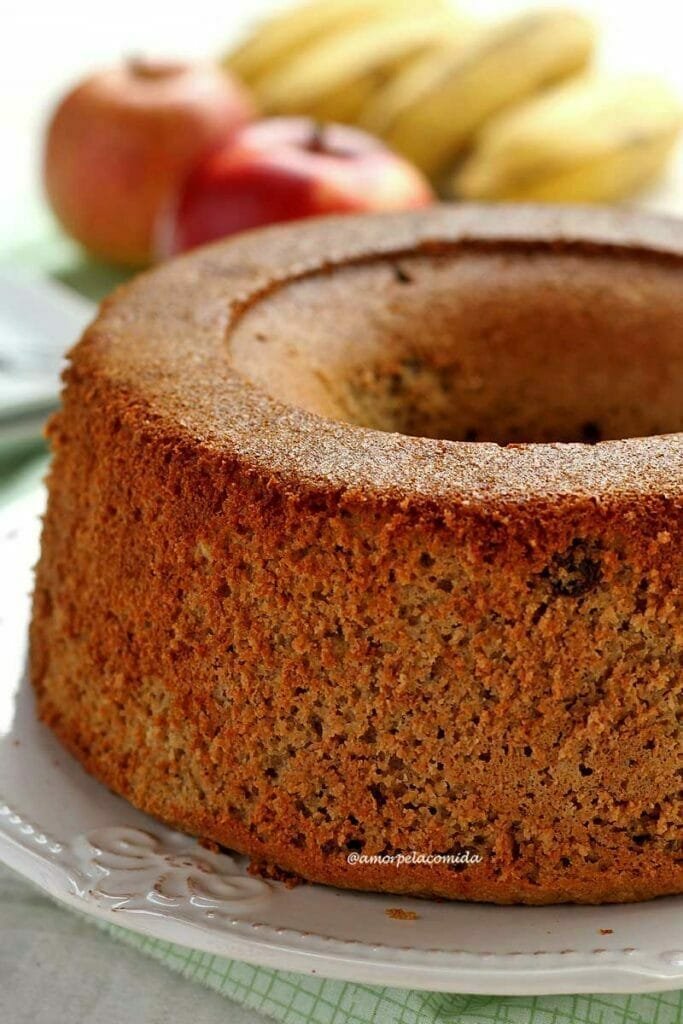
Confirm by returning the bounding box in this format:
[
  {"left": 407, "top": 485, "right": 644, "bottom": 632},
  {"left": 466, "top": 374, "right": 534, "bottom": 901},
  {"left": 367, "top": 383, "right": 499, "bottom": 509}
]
[{"left": 44, "top": 60, "right": 254, "bottom": 265}]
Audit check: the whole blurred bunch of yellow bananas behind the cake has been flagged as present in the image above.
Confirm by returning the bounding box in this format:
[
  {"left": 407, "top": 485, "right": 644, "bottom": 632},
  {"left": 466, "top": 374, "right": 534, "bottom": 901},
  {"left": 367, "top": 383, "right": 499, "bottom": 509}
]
[{"left": 225, "top": 0, "right": 681, "bottom": 202}]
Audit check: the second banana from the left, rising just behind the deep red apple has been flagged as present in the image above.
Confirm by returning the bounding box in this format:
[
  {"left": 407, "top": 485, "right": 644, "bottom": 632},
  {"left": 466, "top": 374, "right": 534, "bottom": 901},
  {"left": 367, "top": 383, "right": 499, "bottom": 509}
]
[{"left": 256, "top": 12, "right": 473, "bottom": 122}]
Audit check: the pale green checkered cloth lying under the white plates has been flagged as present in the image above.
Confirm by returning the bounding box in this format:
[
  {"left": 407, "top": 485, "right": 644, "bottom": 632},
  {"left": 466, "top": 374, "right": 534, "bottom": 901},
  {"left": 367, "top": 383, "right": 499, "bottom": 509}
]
[{"left": 0, "top": 218, "right": 683, "bottom": 1024}]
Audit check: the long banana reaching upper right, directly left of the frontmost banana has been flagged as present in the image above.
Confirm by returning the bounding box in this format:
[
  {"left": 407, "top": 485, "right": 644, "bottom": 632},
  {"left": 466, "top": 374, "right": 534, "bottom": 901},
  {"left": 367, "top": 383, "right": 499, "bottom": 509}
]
[{"left": 361, "top": 10, "right": 594, "bottom": 175}]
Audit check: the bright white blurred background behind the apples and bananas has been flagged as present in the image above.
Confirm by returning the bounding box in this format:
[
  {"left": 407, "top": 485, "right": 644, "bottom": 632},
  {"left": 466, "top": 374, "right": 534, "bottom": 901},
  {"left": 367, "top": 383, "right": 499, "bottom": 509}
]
[{"left": 0, "top": 0, "right": 683, "bottom": 248}]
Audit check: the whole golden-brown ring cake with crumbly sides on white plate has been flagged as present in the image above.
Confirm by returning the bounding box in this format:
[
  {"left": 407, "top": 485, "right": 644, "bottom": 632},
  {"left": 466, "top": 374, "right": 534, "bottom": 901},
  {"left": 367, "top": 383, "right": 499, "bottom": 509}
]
[{"left": 31, "top": 206, "right": 683, "bottom": 903}]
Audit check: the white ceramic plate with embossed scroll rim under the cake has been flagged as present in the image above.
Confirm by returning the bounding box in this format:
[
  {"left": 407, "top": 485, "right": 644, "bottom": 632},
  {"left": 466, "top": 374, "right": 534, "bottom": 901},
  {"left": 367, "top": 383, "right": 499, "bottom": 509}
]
[{"left": 0, "top": 495, "right": 683, "bottom": 994}]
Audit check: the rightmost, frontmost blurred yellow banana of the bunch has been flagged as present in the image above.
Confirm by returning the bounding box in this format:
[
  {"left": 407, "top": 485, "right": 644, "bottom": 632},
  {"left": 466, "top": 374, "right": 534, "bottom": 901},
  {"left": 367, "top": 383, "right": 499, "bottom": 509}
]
[{"left": 454, "top": 77, "right": 683, "bottom": 203}]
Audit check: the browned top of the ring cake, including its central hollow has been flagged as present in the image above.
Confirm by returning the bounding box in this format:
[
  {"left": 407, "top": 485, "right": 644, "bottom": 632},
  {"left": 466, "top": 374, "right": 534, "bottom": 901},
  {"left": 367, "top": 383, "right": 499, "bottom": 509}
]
[{"left": 71, "top": 206, "right": 683, "bottom": 510}]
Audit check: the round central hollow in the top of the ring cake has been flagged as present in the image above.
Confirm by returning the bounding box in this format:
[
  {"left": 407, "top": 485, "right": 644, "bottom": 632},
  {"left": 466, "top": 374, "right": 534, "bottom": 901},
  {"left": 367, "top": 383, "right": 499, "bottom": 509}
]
[{"left": 230, "top": 247, "right": 683, "bottom": 444}]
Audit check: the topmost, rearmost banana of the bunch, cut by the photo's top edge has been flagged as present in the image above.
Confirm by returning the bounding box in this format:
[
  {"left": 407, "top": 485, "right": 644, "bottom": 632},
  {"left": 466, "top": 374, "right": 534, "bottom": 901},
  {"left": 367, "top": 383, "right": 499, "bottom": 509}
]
[{"left": 224, "top": 0, "right": 447, "bottom": 86}]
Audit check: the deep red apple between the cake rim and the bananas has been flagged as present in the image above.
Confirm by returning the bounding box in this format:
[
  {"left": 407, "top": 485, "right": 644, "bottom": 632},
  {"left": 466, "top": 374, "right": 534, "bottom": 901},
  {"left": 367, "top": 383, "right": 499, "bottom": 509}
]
[{"left": 159, "top": 118, "right": 433, "bottom": 256}]
